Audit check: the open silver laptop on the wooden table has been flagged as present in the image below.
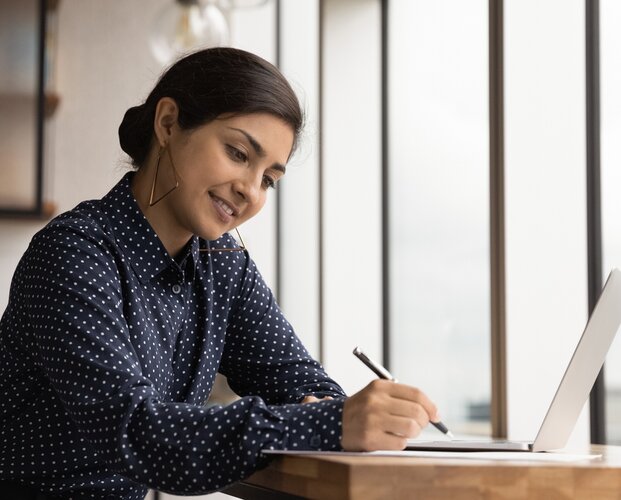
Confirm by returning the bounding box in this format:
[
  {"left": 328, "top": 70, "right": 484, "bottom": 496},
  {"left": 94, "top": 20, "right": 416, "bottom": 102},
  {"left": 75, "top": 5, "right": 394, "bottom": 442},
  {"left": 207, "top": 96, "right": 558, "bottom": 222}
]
[{"left": 406, "top": 269, "right": 621, "bottom": 451}]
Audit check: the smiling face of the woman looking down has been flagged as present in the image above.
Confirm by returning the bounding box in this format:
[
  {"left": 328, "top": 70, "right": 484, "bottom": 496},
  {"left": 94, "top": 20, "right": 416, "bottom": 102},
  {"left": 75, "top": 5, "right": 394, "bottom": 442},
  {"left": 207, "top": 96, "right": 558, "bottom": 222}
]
[{"left": 160, "top": 113, "right": 294, "bottom": 246}]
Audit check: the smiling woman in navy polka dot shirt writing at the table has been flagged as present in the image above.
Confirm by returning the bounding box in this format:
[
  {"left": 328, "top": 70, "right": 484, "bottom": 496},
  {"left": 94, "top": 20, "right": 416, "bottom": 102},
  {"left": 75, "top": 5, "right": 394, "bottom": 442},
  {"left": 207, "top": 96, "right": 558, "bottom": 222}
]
[{"left": 0, "top": 48, "right": 438, "bottom": 499}]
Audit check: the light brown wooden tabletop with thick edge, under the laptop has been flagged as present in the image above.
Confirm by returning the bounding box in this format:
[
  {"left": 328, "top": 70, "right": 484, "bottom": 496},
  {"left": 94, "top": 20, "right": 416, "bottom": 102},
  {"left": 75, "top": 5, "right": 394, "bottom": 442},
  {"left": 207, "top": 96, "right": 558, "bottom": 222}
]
[{"left": 226, "top": 446, "right": 621, "bottom": 500}]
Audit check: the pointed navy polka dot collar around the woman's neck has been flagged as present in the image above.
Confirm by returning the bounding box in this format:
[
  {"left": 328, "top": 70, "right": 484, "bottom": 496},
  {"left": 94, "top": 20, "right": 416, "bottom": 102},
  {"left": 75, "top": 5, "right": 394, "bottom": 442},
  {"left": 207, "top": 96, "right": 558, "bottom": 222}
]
[{"left": 102, "top": 172, "right": 199, "bottom": 283}]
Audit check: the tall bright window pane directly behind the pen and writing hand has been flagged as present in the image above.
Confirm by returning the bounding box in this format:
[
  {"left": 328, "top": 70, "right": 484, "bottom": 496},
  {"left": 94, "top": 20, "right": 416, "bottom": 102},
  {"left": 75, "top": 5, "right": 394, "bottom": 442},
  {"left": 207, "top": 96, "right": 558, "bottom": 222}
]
[{"left": 388, "top": 0, "right": 491, "bottom": 434}]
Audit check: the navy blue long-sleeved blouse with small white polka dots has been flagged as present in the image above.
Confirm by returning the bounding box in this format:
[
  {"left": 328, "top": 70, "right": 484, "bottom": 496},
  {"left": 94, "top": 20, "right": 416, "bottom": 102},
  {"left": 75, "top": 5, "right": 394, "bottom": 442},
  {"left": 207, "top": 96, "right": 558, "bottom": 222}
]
[{"left": 0, "top": 173, "right": 344, "bottom": 499}]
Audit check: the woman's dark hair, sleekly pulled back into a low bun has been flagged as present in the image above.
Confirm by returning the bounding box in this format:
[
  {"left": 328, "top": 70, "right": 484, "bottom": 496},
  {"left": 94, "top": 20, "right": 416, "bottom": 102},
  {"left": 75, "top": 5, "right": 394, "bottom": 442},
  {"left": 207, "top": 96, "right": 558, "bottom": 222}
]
[{"left": 119, "top": 47, "right": 304, "bottom": 167}]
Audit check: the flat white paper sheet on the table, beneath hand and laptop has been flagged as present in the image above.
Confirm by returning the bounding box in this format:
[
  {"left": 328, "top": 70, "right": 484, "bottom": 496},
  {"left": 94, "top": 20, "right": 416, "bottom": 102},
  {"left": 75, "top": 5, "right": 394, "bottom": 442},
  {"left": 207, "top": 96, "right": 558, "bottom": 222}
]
[{"left": 262, "top": 450, "right": 601, "bottom": 462}]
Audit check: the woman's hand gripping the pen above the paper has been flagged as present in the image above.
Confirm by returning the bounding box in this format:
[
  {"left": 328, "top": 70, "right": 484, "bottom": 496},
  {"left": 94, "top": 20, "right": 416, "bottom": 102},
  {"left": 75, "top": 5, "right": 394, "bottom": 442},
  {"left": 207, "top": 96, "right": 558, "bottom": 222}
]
[{"left": 341, "top": 379, "right": 440, "bottom": 451}]
